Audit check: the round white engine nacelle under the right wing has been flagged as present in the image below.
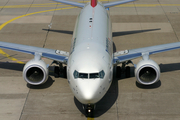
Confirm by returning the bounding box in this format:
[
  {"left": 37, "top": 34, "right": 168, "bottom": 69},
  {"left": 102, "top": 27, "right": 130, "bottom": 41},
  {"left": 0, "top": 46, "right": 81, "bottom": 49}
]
[{"left": 135, "top": 59, "right": 160, "bottom": 85}]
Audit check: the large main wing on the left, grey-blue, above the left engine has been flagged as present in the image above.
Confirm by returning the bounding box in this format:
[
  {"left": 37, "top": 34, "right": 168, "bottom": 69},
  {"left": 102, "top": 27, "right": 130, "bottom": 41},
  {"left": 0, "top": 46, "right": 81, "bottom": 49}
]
[{"left": 0, "top": 42, "right": 69, "bottom": 64}]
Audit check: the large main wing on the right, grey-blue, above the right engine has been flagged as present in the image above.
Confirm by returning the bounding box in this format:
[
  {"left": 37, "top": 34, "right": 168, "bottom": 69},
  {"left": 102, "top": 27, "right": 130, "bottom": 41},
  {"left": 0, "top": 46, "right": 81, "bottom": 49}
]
[{"left": 113, "top": 42, "right": 180, "bottom": 64}]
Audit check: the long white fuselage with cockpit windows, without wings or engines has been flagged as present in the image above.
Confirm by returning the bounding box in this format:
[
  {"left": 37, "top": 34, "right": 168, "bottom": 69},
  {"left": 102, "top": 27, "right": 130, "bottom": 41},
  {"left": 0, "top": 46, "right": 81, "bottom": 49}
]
[{"left": 67, "top": 3, "right": 113, "bottom": 104}]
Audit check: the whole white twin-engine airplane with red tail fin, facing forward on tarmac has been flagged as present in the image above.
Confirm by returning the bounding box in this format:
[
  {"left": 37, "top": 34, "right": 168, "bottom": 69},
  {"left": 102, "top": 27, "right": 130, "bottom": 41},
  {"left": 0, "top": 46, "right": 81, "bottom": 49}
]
[{"left": 0, "top": 0, "right": 180, "bottom": 114}]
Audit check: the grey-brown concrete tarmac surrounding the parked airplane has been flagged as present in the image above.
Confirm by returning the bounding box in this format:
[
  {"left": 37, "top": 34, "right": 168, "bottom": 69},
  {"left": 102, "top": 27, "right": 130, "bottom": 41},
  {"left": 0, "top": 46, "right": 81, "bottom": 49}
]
[{"left": 0, "top": 0, "right": 180, "bottom": 120}]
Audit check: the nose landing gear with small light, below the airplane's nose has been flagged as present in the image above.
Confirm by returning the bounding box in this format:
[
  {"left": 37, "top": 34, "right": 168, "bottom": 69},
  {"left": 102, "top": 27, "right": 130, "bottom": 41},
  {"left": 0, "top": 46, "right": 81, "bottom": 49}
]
[{"left": 83, "top": 104, "right": 95, "bottom": 117}]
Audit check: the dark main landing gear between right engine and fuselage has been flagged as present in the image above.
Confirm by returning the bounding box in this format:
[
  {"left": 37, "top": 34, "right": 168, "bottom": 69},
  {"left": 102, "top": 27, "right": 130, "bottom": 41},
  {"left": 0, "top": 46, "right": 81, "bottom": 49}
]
[{"left": 116, "top": 61, "right": 133, "bottom": 78}]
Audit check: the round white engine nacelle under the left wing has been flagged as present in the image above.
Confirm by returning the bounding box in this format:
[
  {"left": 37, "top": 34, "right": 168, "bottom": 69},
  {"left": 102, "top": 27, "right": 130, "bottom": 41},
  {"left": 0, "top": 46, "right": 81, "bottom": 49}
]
[{"left": 23, "top": 59, "right": 49, "bottom": 85}]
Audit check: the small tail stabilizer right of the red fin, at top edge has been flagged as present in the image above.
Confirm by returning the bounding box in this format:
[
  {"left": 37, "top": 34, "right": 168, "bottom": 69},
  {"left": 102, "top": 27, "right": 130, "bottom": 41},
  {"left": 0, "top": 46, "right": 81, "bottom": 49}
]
[{"left": 103, "top": 0, "right": 135, "bottom": 8}]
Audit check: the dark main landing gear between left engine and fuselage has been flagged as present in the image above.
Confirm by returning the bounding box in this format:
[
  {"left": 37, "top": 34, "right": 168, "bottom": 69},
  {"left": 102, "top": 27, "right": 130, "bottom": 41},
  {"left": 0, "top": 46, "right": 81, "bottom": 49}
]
[{"left": 52, "top": 61, "right": 67, "bottom": 78}]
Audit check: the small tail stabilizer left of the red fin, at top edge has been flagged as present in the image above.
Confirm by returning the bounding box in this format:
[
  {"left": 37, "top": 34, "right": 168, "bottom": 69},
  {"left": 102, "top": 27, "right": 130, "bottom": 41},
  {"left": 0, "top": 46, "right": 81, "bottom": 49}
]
[{"left": 53, "top": 0, "right": 85, "bottom": 8}]
